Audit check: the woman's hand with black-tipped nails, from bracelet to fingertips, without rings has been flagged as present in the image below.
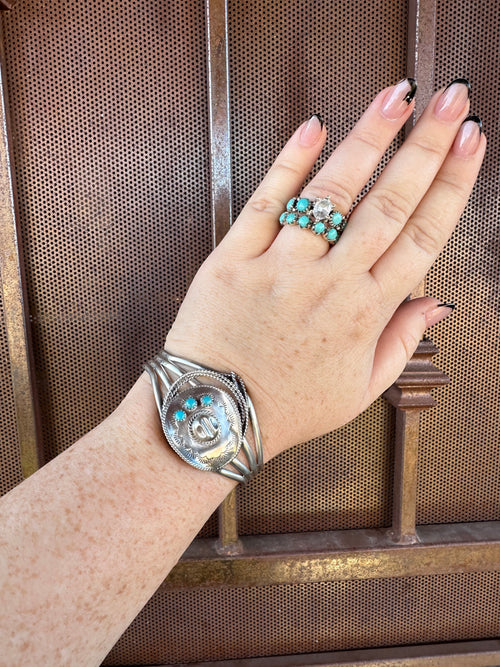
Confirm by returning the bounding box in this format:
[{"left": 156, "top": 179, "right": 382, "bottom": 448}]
[{"left": 166, "top": 80, "right": 486, "bottom": 458}]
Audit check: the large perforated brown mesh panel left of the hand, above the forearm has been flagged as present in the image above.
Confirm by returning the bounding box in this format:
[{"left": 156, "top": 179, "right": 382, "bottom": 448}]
[{"left": 3, "top": 0, "right": 211, "bottom": 459}]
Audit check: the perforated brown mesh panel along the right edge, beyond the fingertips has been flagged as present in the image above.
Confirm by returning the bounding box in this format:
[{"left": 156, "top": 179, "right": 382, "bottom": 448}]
[{"left": 417, "top": 0, "right": 500, "bottom": 523}]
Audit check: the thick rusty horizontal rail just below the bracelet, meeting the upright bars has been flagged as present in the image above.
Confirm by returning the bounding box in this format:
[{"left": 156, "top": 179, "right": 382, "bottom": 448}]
[{"left": 163, "top": 522, "right": 500, "bottom": 588}]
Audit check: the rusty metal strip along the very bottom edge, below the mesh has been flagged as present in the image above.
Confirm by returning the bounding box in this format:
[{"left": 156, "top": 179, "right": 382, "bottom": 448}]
[{"left": 164, "top": 639, "right": 500, "bottom": 667}]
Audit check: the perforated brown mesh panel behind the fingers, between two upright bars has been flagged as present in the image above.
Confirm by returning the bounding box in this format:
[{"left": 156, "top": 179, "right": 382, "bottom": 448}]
[{"left": 229, "top": 0, "right": 407, "bottom": 534}]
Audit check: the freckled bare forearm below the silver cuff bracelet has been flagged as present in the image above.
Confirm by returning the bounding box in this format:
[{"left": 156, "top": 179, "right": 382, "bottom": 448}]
[{"left": 0, "top": 376, "right": 238, "bottom": 667}]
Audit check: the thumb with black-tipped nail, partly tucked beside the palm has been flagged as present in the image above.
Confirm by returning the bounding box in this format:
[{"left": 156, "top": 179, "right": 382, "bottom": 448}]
[{"left": 369, "top": 297, "right": 455, "bottom": 400}]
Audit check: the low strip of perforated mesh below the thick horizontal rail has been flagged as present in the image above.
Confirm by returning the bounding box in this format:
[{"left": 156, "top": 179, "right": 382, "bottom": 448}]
[{"left": 105, "top": 572, "right": 500, "bottom": 665}]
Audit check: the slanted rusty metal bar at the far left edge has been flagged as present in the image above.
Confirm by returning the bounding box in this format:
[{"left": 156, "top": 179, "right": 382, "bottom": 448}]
[{"left": 0, "top": 27, "right": 42, "bottom": 477}]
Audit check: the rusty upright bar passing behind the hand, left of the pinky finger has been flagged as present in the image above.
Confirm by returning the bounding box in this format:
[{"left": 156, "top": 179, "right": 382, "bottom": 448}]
[{"left": 205, "top": 0, "right": 239, "bottom": 552}]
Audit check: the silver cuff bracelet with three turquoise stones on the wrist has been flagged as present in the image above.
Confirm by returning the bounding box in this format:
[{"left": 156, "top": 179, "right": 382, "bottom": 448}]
[{"left": 144, "top": 350, "right": 264, "bottom": 483}]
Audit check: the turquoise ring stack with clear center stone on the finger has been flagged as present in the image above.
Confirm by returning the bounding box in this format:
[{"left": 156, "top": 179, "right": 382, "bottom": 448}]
[{"left": 279, "top": 197, "right": 347, "bottom": 245}]
